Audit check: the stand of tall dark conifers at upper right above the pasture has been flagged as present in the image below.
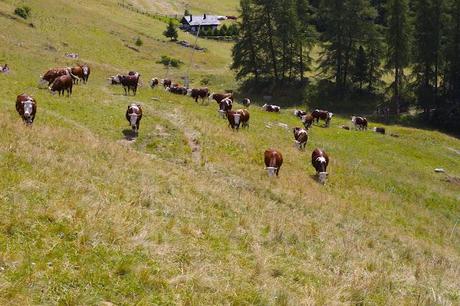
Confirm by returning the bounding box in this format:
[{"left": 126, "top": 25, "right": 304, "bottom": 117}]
[{"left": 232, "top": 0, "right": 460, "bottom": 133}]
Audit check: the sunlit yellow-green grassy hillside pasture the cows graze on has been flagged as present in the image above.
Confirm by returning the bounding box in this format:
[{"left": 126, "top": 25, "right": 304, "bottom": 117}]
[{"left": 0, "top": 0, "right": 460, "bottom": 305}]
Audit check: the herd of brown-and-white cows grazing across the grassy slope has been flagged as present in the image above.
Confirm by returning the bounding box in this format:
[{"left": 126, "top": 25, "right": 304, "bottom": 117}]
[{"left": 16, "top": 64, "right": 385, "bottom": 184}]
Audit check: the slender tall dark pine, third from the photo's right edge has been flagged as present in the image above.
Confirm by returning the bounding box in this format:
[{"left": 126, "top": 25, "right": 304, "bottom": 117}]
[{"left": 386, "top": 0, "right": 410, "bottom": 115}]
